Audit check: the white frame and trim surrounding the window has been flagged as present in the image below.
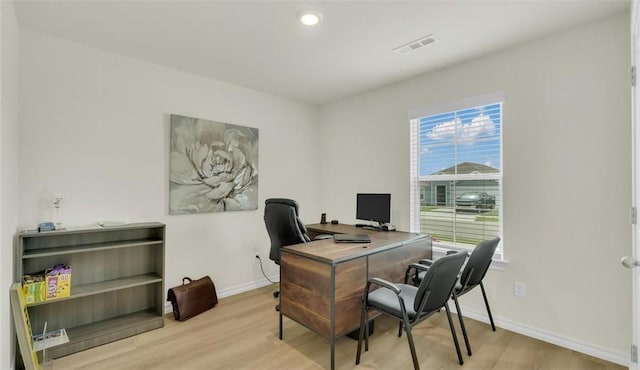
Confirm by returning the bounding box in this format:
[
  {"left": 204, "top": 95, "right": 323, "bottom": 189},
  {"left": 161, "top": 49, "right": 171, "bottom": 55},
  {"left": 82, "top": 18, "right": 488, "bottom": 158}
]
[{"left": 408, "top": 91, "right": 508, "bottom": 264}]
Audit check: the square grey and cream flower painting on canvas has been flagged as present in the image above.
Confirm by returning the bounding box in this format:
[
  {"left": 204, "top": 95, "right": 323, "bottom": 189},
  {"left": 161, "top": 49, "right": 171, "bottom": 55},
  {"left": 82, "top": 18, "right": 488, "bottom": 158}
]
[{"left": 169, "top": 115, "right": 258, "bottom": 214}]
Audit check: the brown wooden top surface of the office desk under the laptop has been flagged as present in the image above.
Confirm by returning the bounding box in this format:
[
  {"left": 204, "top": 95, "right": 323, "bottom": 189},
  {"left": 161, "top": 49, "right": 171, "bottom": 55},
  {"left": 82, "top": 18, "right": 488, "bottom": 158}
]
[{"left": 282, "top": 224, "right": 430, "bottom": 264}]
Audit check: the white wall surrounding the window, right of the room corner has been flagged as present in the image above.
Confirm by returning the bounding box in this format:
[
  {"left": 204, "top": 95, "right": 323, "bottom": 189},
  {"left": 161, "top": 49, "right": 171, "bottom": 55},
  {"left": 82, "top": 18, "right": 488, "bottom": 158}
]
[{"left": 320, "top": 14, "right": 631, "bottom": 363}]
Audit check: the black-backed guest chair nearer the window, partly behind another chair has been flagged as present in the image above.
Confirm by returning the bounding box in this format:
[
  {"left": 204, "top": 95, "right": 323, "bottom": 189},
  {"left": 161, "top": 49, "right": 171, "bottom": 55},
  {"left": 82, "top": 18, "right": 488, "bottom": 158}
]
[{"left": 405, "top": 237, "right": 500, "bottom": 356}]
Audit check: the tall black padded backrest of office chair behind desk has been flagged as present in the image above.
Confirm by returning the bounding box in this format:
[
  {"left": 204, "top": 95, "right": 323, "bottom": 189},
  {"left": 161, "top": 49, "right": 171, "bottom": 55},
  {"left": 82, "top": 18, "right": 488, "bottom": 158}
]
[{"left": 264, "top": 198, "right": 309, "bottom": 264}]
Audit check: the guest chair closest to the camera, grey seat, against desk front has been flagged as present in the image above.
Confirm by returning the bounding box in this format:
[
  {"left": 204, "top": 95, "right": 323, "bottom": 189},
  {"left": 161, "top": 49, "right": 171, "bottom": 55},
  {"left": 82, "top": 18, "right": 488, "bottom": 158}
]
[{"left": 356, "top": 252, "right": 466, "bottom": 369}]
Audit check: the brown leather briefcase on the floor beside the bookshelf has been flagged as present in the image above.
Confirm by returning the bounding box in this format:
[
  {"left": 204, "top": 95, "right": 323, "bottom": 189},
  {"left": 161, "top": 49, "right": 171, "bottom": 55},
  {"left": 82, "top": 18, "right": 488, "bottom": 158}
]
[{"left": 167, "top": 276, "right": 218, "bottom": 321}]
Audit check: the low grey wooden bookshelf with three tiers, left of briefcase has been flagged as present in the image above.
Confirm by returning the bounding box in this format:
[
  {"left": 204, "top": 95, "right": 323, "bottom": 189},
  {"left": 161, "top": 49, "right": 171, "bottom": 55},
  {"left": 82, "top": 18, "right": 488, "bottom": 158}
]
[{"left": 15, "top": 222, "right": 165, "bottom": 358}]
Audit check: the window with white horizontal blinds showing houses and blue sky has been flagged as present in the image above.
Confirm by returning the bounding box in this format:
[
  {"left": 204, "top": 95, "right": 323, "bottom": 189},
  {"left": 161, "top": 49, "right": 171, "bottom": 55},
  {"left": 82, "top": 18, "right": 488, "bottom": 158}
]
[{"left": 409, "top": 93, "right": 504, "bottom": 259}]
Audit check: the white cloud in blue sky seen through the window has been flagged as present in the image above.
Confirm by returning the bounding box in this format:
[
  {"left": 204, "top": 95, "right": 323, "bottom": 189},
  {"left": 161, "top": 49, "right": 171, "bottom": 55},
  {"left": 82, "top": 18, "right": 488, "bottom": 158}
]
[{"left": 426, "top": 113, "right": 496, "bottom": 144}]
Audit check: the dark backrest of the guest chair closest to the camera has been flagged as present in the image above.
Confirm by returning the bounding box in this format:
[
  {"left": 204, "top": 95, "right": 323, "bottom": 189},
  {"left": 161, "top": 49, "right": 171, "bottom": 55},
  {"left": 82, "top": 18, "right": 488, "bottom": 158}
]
[{"left": 413, "top": 252, "right": 467, "bottom": 312}]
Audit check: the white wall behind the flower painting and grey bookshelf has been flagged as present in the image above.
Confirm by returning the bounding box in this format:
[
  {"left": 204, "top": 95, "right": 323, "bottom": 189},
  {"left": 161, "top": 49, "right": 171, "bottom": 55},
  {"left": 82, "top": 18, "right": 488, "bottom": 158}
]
[{"left": 19, "top": 29, "right": 319, "bottom": 306}]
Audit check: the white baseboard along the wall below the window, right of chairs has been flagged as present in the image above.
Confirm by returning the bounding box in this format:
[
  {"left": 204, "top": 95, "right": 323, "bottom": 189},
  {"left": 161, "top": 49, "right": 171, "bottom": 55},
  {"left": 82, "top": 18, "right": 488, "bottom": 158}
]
[{"left": 451, "top": 304, "right": 629, "bottom": 367}]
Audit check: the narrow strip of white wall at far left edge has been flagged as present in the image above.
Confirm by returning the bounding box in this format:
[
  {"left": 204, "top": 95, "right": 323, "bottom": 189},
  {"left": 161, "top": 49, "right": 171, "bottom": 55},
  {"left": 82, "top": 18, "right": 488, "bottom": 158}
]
[{"left": 0, "top": 1, "right": 19, "bottom": 369}]
